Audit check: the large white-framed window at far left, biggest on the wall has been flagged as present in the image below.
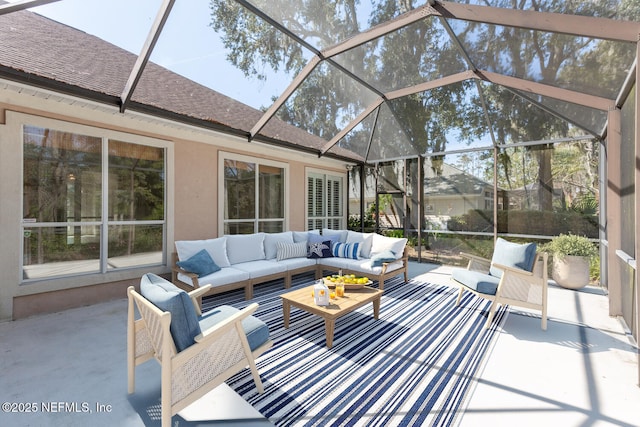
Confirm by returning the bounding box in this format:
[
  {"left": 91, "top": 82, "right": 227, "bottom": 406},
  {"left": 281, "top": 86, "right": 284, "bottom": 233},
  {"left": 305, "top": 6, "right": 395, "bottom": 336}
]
[{"left": 22, "top": 126, "right": 166, "bottom": 281}]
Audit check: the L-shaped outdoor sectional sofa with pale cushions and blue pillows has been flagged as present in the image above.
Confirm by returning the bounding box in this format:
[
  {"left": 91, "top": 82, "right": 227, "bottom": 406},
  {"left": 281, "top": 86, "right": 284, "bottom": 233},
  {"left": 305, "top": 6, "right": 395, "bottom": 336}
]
[{"left": 172, "top": 229, "right": 408, "bottom": 300}]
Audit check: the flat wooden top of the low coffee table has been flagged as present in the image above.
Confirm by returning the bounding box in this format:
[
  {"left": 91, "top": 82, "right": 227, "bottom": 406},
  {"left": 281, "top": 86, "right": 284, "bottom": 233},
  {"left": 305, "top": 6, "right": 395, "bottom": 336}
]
[{"left": 281, "top": 285, "right": 384, "bottom": 317}]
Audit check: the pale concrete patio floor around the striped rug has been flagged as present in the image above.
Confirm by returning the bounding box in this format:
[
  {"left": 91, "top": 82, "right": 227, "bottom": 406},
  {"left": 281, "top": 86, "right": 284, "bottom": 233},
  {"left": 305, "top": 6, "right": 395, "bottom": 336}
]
[{"left": 0, "top": 262, "right": 640, "bottom": 427}]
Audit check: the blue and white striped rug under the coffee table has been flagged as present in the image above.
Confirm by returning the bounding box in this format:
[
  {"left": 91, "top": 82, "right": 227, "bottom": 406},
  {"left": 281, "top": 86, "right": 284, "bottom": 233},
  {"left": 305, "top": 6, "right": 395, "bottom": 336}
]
[{"left": 205, "top": 276, "right": 506, "bottom": 426}]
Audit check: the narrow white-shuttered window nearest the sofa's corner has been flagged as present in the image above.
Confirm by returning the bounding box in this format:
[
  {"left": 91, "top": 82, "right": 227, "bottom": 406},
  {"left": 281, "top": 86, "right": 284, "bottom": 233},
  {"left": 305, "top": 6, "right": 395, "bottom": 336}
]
[{"left": 307, "top": 172, "right": 345, "bottom": 230}]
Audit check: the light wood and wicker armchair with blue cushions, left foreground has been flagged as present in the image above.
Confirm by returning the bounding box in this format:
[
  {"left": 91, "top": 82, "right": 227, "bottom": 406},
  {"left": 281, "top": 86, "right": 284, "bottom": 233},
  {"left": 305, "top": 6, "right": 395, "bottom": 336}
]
[{"left": 127, "top": 274, "right": 272, "bottom": 427}]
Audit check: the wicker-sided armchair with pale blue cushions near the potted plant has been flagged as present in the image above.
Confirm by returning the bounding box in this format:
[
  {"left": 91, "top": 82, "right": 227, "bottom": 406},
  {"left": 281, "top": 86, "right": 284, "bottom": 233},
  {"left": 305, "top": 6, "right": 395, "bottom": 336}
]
[{"left": 451, "top": 239, "right": 548, "bottom": 330}]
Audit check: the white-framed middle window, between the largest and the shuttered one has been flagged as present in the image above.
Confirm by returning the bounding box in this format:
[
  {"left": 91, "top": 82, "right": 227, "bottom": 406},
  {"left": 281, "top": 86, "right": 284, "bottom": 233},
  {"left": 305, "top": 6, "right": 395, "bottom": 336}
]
[{"left": 220, "top": 153, "right": 287, "bottom": 234}]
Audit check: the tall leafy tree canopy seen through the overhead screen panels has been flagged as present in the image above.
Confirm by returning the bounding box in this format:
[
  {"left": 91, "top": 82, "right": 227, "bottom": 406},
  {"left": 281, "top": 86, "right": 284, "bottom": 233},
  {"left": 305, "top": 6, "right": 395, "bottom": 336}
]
[{"left": 211, "top": 0, "right": 640, "bottom": 217}]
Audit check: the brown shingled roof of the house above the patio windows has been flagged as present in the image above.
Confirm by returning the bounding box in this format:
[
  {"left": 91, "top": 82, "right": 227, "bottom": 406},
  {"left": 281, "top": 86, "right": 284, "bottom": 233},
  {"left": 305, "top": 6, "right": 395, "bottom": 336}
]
[{"left": 0, "top": 7, "right": 362, "bottom": 161}]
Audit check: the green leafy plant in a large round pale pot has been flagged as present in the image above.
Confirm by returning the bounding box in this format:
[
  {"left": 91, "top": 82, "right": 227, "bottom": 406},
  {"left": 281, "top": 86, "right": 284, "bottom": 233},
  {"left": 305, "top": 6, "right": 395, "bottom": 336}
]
[{"left": 541, "top": 234, "right": 598, "bottom": 289}]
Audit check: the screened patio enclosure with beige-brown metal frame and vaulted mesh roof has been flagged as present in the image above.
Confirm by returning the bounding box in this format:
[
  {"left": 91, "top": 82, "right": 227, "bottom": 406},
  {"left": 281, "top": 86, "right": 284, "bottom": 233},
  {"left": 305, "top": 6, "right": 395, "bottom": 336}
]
[{"left": 0, "top": 0, "right": 640, "bottom": 374}]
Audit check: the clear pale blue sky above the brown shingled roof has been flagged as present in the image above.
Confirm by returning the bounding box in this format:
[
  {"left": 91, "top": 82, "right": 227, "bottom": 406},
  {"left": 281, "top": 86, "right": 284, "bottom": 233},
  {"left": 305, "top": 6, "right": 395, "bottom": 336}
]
[{"left": 19, "top": 0, "right": 293, "bottom": 108}]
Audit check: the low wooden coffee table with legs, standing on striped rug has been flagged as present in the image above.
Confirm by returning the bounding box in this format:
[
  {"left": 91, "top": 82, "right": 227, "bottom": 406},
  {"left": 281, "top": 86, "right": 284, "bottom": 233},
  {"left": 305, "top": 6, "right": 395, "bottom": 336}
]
[{"left": 281, "top": 286, "right": 384, "bottom": 348}]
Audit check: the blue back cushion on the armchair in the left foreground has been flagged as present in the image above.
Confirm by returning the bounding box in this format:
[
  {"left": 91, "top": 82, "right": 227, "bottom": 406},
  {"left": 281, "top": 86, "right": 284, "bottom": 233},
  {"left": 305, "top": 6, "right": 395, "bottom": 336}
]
[{"left": 140, "top": 273, "right": 201, "bottom": 352}]
